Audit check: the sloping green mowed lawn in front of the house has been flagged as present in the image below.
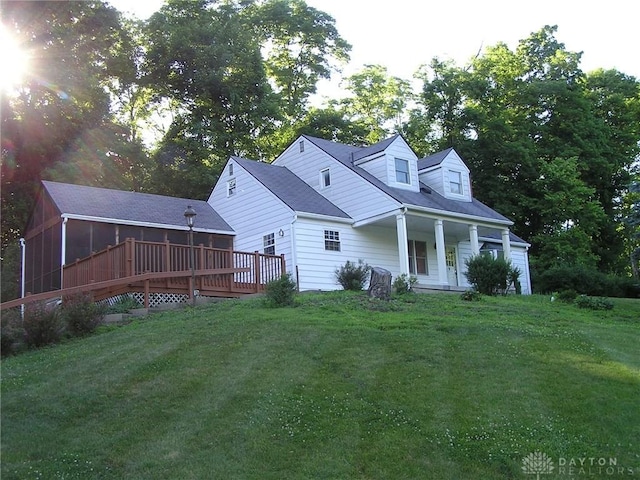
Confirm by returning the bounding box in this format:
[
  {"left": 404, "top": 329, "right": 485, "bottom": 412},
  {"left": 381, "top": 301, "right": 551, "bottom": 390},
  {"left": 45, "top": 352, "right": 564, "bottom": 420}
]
[{"left": 1, "top": 292, "right": 640, "bottom": 480}]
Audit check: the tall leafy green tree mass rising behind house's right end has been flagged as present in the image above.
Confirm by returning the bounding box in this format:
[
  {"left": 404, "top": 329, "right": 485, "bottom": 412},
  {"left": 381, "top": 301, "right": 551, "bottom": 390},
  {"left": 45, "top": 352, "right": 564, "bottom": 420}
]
[{"left": 410, "top": 26, "right": 640, "bottom": 270}]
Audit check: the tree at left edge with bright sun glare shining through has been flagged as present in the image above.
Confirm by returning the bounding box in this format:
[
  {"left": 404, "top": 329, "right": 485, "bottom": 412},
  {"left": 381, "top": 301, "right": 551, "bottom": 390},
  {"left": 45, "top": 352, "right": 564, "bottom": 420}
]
[{"left": 1, "top": 1, "right": 138, "bottom": 248}]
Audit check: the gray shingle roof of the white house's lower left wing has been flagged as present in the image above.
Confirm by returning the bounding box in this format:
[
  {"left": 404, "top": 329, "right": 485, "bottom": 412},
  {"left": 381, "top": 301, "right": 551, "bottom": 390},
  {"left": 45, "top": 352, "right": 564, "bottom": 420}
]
[{"left": 232, "top": 157, "right": 350, "bottom": 218}]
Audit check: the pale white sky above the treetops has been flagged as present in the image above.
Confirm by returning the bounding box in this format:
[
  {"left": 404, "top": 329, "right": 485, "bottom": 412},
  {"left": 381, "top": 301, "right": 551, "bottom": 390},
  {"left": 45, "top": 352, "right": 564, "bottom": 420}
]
[{"left": 109, "top": 0, "right": 640, "bottom": 99}]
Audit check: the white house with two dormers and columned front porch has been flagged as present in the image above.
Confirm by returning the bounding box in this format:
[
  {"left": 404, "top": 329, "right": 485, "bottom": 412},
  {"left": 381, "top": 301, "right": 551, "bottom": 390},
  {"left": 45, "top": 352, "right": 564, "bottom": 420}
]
[{"left": 208, "top": 135, "right": 531, "bottom": 294}]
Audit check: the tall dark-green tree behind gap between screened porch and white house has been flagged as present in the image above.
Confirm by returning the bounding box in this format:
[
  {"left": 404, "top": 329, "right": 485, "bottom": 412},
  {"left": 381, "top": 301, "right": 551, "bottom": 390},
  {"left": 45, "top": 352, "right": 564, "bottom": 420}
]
[{"left": 145, "top": 0, "right": 278, "bottom": 198}]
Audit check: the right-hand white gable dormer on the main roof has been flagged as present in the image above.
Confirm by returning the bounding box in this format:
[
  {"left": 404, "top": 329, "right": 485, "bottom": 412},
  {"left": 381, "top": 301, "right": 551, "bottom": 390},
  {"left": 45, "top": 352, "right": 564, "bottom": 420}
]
[{"left": 418, "top": 148, "right": 472, "bottom": 202}]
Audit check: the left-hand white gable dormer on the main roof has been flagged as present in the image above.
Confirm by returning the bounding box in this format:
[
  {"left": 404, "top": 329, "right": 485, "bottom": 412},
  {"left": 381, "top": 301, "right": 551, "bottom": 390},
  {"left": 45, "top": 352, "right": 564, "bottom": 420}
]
[{"left": 352, "top": 135, "right": 420, "bottom": 192}]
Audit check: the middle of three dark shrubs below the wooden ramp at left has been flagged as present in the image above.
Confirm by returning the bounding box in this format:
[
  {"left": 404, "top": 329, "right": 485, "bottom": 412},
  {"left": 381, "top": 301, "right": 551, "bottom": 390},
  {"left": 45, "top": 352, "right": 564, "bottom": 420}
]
[{"left": 22, "top": 302, "right": 64, "bottom": 348}]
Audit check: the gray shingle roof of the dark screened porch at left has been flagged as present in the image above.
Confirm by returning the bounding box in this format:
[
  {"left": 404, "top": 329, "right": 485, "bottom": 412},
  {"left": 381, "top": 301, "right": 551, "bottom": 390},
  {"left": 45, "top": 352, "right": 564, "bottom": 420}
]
[{"left": 42, "top": 180, "right": 233, "bottom": 234}]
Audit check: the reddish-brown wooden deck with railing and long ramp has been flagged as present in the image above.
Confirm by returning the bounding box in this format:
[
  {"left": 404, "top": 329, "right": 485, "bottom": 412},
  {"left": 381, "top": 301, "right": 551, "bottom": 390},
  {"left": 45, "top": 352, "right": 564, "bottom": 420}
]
[{"left": 0, "top": 239, "right": 286, "bottom": 310}]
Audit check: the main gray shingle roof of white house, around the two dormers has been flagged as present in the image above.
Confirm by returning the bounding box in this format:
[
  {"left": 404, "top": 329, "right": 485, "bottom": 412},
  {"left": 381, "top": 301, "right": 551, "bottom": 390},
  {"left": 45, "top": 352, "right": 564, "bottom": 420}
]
[{"left": 304, "top": 135, "right": 511, "bottom": 222}]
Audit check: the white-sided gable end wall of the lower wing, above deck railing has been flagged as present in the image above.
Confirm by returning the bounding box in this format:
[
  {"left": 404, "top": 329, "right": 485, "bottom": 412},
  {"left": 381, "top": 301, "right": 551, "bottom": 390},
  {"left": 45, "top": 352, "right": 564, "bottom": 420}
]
[{"left": 207, "top": 162, "right": 294, "bottom": 270}]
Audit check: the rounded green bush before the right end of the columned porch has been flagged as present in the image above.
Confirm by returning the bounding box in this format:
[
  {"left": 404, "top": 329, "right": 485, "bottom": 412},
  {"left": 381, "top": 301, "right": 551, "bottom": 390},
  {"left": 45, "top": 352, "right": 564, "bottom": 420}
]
[{"left": 465, "top": 254, "right": 520, "bottom": 295}]
